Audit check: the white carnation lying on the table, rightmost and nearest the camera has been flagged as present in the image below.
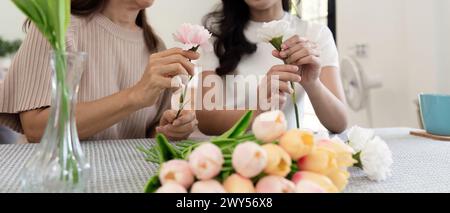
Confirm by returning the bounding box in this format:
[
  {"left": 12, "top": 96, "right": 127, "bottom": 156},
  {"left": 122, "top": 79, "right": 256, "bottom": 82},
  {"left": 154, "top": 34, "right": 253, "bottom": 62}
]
[{"left": 360, "top": 137, "right": 393, "bottom": 181}]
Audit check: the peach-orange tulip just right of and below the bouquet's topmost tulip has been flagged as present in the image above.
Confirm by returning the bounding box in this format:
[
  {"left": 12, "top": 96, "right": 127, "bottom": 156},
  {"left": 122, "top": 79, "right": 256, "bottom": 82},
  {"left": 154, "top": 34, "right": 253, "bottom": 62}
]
[{"left": 280, "top": 129, "right": 314, "bottom": 160}]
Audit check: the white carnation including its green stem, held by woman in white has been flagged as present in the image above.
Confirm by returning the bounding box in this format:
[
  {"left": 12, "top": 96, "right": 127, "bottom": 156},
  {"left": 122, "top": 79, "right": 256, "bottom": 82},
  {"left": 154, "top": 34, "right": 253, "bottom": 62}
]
[{"left": 258, "top": 20, "right": 300, "bottom": 129}]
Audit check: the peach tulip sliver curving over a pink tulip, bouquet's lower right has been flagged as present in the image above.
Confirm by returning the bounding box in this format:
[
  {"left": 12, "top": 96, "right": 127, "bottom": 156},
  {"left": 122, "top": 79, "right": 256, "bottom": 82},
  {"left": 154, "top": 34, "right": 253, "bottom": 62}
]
[{"left": 292, "top": 171, "right": 339, "bottom": 193}]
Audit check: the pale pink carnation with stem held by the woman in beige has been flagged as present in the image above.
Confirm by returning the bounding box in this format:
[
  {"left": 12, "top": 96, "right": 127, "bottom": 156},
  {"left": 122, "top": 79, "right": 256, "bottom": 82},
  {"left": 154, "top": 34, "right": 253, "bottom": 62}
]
[{"left": 173, "top": 24, "right": 212, "bottom": 118}]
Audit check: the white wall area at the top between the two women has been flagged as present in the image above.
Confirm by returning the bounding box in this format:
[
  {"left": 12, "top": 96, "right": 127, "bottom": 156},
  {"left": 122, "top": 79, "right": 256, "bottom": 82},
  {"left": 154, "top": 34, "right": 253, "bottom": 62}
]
[{"left": 148, "top": 0, "right": 219, "bottom": 48}]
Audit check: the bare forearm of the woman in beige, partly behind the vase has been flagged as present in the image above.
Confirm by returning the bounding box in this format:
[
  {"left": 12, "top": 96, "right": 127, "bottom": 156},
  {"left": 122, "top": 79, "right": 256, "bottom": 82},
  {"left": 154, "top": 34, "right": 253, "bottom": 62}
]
[{"left": 20, "top": 89, "right": 141, "bottom": 142}]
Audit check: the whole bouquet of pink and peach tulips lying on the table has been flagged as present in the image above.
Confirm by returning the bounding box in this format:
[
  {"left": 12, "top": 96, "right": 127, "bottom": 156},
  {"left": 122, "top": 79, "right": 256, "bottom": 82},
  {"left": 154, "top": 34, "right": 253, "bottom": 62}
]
[{"left": 141, "top": 111, "right": 356, "bottom": 193}]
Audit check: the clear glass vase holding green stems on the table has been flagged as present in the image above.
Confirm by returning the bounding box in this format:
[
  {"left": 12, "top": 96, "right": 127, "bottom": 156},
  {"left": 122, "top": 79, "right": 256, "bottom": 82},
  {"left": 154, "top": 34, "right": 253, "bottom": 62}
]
[{"left": 21, "top": 52, "right": 90, "bottom": 193}]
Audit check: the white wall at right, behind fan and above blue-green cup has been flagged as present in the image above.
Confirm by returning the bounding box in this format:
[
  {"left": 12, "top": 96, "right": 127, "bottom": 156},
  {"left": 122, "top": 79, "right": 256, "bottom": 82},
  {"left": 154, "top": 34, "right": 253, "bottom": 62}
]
[{"left": 337, "top": 0, "right": 450, "bottom": 127}]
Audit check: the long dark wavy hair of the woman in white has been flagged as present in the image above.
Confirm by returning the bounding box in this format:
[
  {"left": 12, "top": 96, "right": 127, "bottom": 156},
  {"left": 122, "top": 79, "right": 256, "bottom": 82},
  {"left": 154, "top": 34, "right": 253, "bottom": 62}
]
[{"left": 203, "top": 0, "right": 292, "bottom": 76}]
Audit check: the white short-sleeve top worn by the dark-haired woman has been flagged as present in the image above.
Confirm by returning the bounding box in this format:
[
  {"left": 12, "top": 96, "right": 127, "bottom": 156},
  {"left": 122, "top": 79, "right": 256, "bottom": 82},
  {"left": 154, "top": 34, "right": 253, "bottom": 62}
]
[{"left": 197, "top": 13, "right": 339, "bottom": 128}]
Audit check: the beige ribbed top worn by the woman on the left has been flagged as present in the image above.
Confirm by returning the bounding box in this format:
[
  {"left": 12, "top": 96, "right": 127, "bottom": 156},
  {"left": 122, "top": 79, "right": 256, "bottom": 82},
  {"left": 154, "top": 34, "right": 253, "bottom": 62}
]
[{"left": 0, "top": 14, "right": 170, "bottom": 140}]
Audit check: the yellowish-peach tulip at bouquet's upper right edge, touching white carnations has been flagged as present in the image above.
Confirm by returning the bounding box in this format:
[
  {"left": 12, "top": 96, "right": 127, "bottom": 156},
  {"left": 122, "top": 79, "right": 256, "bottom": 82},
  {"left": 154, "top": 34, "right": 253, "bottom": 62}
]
[{"left": 317, "top": 137, "right": 356, "bottom": 168}]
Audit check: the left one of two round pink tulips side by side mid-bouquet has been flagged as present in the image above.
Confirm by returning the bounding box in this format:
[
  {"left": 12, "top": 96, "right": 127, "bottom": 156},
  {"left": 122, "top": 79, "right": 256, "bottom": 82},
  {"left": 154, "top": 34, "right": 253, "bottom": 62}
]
[{"left": 189, "top": 143, "right": 224, "bottom": 180}]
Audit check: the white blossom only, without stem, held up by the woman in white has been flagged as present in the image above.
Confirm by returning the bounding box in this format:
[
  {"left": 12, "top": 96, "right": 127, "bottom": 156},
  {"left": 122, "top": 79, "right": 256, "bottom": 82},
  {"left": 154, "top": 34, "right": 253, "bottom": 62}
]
[{"left": 258, "top": 20, "right": 294, "bottom": 45}]
